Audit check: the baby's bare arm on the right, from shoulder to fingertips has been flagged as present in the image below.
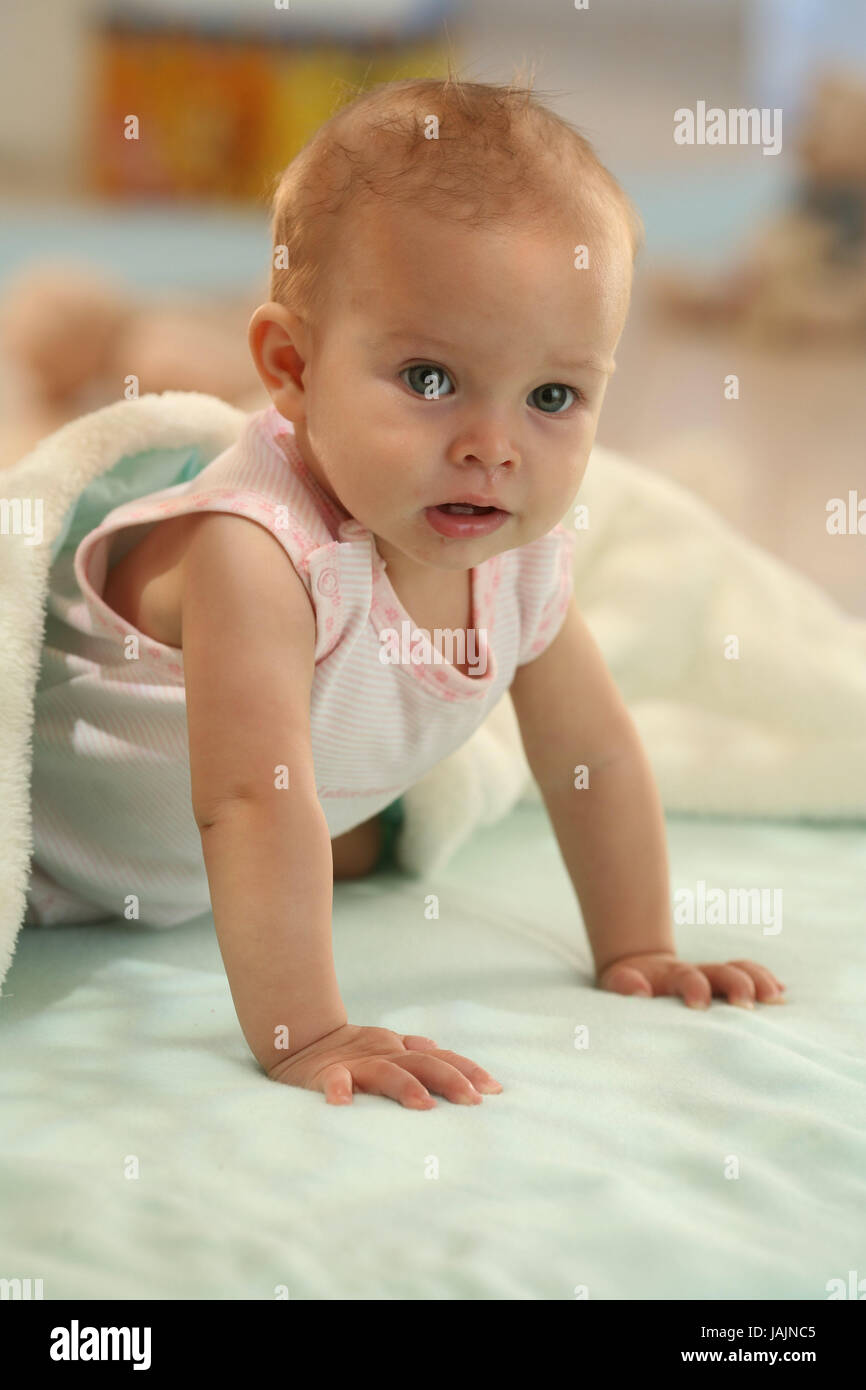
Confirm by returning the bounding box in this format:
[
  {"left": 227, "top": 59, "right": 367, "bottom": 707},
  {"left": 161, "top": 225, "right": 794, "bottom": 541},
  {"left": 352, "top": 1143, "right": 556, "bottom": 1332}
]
[{"left": 510, "top": 598, "right": 783, "bottom": 1006}]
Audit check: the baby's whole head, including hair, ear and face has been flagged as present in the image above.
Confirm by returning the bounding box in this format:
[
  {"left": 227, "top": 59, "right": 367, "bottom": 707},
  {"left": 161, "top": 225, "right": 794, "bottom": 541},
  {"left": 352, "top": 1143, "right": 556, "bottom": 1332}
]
[{"left": 249, "top": 79, "right": 642, "bottom": 570}]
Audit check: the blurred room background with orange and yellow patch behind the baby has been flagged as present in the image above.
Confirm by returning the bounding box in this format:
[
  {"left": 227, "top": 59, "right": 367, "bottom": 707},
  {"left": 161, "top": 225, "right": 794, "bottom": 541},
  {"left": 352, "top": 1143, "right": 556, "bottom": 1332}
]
[{"left": 0, "top": 0, "right": 866, "bottom": 617}]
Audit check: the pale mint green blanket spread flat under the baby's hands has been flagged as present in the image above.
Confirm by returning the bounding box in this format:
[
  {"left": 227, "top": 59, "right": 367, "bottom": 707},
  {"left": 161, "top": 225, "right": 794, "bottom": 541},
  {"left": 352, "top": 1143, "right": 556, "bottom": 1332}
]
[{"left": 0, "top": 805, "right": 866, "bottom": 1300}]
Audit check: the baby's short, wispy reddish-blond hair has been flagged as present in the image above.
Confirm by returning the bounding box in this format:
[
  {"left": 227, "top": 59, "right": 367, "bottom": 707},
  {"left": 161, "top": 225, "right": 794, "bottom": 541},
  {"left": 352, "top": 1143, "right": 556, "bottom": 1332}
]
[{"left": 270, "top": 64, "right": 644, "bottom": 318}]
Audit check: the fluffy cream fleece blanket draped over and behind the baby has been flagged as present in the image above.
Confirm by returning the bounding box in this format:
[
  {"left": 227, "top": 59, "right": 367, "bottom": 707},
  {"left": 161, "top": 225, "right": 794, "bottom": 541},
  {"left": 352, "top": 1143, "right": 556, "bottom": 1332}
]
[{"left": 0, "top": 392, "right": 866, "bottom": 984}]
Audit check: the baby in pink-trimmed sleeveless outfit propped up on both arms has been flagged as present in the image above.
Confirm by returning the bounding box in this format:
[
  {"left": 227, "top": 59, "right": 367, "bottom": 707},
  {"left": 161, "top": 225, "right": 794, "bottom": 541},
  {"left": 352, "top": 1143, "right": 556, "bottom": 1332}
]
[{"left": 32, "top": 79, "right": 784, "bottom": 1109}]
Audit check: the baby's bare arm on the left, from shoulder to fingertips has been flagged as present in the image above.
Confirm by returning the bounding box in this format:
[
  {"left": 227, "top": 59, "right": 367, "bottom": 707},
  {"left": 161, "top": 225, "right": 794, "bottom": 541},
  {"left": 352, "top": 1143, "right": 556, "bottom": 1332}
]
[{"left": 182, "top": 513, "right": 499, "bottom": 1108}]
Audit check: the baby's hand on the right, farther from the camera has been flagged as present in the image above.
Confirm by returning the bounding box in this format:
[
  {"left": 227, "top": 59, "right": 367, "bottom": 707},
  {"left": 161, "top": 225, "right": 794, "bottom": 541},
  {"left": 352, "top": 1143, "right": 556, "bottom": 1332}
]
[{"left": 596, "top": 951, "right": 785, "bottom": 1009}]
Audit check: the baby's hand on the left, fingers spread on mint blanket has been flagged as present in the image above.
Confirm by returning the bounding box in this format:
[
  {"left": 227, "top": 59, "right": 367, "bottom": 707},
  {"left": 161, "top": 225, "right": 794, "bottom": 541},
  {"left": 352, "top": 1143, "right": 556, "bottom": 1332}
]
[{"left": 268, "top": 1023, "right": 502, "bottom": 1111}]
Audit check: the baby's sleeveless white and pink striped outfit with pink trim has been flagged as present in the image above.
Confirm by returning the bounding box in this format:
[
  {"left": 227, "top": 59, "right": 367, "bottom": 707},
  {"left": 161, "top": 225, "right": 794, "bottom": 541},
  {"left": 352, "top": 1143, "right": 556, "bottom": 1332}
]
[{"left": 26, "top": 406, "right": 574, "bottom": 927}]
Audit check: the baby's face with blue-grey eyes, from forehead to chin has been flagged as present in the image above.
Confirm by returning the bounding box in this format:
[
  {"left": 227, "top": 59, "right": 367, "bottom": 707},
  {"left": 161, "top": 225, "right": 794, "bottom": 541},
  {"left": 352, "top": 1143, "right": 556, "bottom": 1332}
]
[{"left": 271, "top": 207, "right": 631, "bottom": 570}]
